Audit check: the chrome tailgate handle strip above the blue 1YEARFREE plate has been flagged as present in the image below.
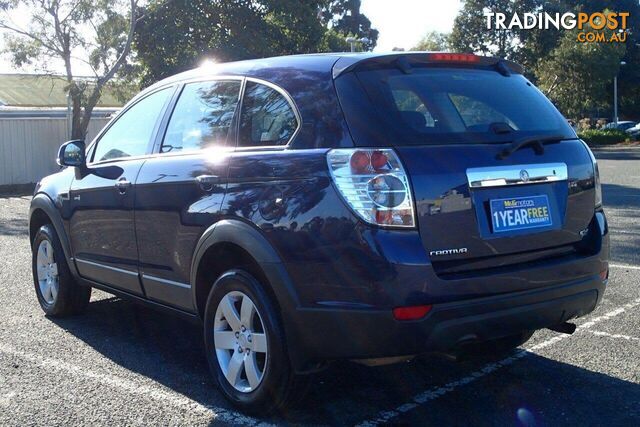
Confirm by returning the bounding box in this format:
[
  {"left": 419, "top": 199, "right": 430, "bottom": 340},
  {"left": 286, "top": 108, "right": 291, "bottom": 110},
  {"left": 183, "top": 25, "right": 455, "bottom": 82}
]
[{"left": 467, "top": 163, "right": 568, "bottom": 188}]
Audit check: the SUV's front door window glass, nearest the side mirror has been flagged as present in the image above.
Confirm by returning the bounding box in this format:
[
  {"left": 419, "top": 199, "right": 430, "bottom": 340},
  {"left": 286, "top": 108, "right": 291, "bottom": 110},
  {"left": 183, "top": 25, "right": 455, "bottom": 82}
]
[{"left": 93, "top": 88, "right": 173, "bottom": 162}]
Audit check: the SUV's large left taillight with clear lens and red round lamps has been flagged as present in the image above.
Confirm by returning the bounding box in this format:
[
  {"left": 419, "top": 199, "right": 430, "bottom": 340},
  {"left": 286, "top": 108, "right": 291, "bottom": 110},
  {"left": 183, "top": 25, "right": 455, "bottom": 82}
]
[{"left": 327, "top": 149, "right": 415, "bottom": 227}]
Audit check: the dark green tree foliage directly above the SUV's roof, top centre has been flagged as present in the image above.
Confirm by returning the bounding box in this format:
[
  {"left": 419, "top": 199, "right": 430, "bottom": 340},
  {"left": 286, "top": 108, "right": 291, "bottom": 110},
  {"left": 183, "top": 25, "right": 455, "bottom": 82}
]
[{"left": 135, "top": 0, "right": 378, "bottom": 84}]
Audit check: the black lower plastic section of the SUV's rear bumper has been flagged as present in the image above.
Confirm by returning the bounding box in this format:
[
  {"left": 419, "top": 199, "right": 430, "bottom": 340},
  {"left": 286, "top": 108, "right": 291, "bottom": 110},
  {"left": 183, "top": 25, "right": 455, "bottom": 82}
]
[{"left": 296, "top": 276, "right": 606, "bottom": 370}]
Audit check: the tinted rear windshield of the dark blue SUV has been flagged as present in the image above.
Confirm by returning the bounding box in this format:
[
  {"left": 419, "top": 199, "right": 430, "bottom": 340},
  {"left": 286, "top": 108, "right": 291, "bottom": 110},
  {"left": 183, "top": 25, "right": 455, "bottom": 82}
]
[{"left": 345, "top": 68, "right": 575, "bottom": 145}]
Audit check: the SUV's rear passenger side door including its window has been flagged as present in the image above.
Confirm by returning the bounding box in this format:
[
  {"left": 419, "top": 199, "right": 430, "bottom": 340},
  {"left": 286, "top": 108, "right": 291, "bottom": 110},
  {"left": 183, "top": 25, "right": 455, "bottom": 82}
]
[{"left": 135, "top": 78, "right": 242, "bottom": 311}]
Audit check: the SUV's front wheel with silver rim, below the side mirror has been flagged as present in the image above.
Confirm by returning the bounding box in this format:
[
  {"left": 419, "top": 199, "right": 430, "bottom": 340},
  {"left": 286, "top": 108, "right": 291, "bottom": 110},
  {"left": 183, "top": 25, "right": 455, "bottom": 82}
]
[{"left": 31, "top": 224, "right": 91, "bottom": 317}]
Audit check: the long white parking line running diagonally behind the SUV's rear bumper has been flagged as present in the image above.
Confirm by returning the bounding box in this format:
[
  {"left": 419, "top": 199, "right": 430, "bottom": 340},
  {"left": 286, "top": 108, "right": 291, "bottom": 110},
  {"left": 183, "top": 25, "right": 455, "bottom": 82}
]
[{"left": 358, "top": 298, "right": 640, "bottom": 427}]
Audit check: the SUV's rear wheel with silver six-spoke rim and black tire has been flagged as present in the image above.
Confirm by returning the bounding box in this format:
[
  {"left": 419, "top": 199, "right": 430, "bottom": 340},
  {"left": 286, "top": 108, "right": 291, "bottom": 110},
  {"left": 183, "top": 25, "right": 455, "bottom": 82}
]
[{"left": 204, "top": 270, "right": 307, "bottom": 415}]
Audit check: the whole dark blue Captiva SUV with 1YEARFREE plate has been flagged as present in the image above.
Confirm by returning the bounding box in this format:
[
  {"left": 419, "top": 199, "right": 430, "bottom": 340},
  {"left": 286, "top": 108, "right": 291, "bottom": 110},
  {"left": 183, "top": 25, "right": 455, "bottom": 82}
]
[{"left": 29, "top": 52, "right": 609, "bottom": 413}]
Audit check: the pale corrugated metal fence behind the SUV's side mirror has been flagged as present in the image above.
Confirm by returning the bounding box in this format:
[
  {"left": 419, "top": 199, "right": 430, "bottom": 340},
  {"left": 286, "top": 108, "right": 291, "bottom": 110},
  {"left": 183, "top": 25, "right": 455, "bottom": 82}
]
[{"left": 0, "top": 117, "right": 109, "bottom": 185}]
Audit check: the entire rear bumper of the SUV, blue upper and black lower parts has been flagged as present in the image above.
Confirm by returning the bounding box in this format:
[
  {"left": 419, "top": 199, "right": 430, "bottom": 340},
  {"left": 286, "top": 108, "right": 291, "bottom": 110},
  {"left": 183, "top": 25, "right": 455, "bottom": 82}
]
[{"left": 282, "top": 212, "right": 609, "bottom": 371}]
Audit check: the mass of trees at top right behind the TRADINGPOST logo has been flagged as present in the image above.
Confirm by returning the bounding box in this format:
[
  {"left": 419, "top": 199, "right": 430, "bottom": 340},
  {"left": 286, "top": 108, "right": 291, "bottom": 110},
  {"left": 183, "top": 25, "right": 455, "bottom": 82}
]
[{"left": 449, "top": 0, "right": 640, "bottom": 119}]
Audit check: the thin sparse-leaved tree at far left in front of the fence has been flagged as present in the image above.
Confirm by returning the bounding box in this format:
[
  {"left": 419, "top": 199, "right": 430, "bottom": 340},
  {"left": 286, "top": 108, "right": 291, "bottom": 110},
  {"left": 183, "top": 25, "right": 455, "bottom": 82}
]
[{"left": 0, "top": 0, "right": 140, "bottom": 139}]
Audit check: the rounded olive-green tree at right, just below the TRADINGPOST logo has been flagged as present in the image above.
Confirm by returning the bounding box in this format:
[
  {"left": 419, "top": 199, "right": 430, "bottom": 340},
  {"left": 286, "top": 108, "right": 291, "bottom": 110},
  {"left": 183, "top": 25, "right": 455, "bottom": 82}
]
[{"left": 534, "top": 25, "right": 626, "bottom": 119}]
